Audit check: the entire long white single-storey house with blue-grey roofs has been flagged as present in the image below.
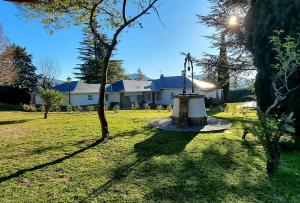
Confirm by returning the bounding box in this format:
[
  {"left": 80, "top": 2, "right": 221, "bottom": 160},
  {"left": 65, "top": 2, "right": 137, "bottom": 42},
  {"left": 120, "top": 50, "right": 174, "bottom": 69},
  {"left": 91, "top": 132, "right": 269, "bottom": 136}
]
[{"left": 34, "top": 75, "right": 223, "bottom": 109}]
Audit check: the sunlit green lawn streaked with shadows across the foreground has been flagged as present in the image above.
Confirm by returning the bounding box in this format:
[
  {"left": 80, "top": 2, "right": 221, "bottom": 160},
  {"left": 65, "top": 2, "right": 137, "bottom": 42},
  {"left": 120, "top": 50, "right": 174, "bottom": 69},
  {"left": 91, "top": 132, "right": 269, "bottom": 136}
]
[{"left": 0, "top": 105, "right": 300, "bottom": 202}]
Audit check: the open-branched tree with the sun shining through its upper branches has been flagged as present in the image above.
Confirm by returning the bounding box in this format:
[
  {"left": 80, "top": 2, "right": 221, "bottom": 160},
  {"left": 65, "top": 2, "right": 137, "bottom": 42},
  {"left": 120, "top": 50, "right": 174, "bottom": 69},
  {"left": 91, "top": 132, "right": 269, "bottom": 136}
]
[{"left": 197, "top": 0, "right": 255, "bottom": 100}]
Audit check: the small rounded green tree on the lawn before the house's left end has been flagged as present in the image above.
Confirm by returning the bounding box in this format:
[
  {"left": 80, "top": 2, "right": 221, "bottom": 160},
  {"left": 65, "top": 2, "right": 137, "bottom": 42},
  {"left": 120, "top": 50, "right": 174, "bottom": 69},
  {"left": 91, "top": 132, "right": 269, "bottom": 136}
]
[{"left": 42, "top": 89, "right": 65, "bottom": 119}]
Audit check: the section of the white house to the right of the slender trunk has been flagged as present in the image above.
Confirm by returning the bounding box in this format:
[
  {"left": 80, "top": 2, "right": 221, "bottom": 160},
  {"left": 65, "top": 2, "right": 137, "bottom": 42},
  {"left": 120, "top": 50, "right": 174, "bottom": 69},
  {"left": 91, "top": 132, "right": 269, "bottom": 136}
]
[{"left": 105, "top": 75, "right": 223, "bottom": 109}]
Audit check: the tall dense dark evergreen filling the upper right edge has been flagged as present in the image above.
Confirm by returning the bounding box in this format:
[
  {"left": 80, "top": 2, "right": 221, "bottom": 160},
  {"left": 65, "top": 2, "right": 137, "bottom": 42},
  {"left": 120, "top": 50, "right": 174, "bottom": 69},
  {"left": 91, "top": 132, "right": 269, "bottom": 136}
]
[{"left": 246, "top": 0, "right": 300, "bottom": 135}]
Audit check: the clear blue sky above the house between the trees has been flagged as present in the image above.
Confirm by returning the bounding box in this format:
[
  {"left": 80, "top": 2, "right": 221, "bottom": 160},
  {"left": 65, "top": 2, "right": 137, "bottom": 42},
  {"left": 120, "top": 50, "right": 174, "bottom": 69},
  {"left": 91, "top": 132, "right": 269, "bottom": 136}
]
[{"left": 0, "top": 0, "right": 216, "bottom": 80}]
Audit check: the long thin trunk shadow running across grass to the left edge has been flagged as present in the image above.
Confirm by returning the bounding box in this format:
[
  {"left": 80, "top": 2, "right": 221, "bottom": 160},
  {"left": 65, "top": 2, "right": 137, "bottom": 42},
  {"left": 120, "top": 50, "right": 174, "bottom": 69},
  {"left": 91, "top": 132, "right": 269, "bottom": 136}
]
[{"left": 0, "top": 139, "right": 103, "bottom": 183}]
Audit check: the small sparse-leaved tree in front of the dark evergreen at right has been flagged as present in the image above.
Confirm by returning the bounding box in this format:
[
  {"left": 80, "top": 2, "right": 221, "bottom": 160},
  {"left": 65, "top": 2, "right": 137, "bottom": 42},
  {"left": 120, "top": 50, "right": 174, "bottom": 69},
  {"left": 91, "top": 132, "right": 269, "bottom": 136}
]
[{"left": 243, "top": 31, "right": 300, "bottom": 173}]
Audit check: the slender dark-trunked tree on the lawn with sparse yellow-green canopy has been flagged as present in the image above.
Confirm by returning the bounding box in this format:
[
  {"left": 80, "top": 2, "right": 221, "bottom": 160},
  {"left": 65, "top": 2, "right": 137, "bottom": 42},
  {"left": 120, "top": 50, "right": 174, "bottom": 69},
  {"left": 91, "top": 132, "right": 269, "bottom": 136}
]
[{"left": 21, "top": 0, "right": 158, "bottom": 139}]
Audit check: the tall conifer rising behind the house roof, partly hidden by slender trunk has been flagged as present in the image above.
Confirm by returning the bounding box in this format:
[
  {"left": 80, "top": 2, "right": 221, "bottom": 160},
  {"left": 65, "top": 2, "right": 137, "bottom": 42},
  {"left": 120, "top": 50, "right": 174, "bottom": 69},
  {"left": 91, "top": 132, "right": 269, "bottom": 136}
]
[{"left": 74, "top": 27, "right": 126, "bottom": 84}]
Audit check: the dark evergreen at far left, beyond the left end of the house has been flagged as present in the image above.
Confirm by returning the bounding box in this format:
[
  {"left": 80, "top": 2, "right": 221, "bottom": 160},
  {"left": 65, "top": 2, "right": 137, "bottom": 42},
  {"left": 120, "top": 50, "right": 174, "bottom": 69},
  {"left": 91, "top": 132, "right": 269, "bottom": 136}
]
[{"left": 13, "top": 45, "right": 38, "bottom": 89}]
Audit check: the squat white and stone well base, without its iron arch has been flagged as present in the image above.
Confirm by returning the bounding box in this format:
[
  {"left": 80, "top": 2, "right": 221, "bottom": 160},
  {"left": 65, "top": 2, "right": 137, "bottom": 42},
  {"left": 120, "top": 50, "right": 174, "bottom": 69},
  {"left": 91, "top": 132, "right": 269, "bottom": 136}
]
[{"left": 172, "top": 94, "right": 207, "bottom": 127}]
